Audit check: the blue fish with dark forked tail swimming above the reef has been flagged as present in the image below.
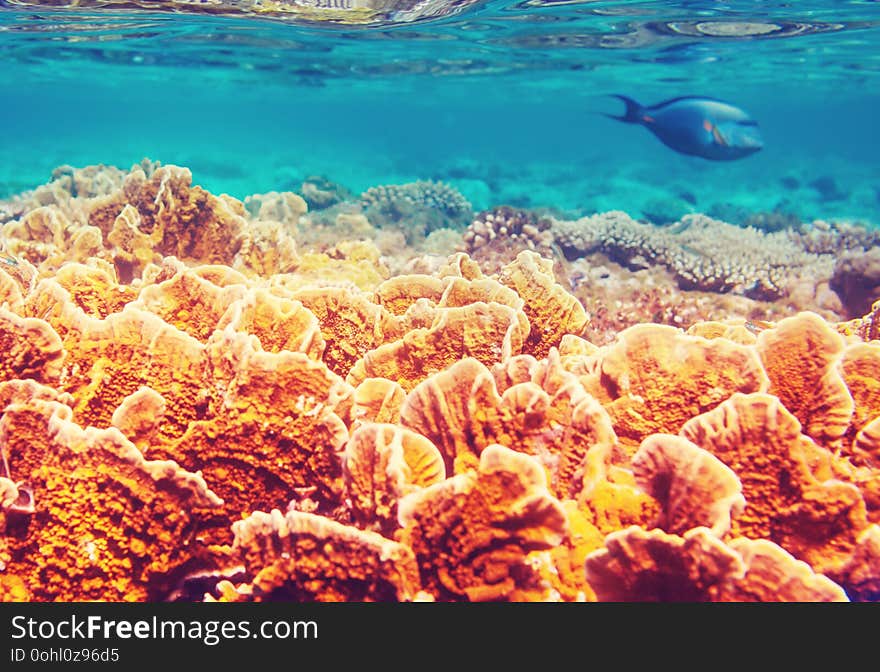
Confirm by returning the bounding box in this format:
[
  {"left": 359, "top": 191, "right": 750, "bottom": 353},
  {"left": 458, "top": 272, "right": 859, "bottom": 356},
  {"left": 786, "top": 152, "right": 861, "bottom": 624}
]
[{"left": 605, "top": 94, "right": 764, "bottom": 161}]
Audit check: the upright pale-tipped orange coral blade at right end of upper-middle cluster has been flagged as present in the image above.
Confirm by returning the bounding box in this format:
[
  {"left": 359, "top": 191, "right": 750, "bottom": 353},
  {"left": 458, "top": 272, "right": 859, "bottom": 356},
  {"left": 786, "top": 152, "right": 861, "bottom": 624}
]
[{"left": 500, "top": 250, "right": 589, "bottom": 358}]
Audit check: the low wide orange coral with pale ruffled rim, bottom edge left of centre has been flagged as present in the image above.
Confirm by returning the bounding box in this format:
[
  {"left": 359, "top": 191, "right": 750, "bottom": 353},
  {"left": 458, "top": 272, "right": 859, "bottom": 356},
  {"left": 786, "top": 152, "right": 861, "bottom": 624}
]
[{"left": 221, "top": 510, "right": 420, "bottom": 602}]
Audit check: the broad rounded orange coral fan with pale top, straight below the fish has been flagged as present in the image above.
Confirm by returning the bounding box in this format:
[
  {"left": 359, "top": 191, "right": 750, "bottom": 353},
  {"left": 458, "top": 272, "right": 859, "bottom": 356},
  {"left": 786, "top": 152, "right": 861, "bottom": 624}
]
[{"left": 587, "top": 324, "right": 768, "bottom": 446}]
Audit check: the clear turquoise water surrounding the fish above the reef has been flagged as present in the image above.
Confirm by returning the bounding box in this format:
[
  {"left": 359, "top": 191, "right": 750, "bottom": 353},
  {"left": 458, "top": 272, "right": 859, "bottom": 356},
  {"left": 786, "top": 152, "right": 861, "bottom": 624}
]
[{"left": 0, "top": 0, "right": 880, "bottom": 225}]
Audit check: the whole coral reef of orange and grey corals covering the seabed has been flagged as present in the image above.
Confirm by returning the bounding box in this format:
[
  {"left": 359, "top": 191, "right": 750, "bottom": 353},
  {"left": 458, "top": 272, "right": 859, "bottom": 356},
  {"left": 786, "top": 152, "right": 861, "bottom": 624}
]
[{"left": 0, "top": 161, "right": 880, "bottom": 601}]
